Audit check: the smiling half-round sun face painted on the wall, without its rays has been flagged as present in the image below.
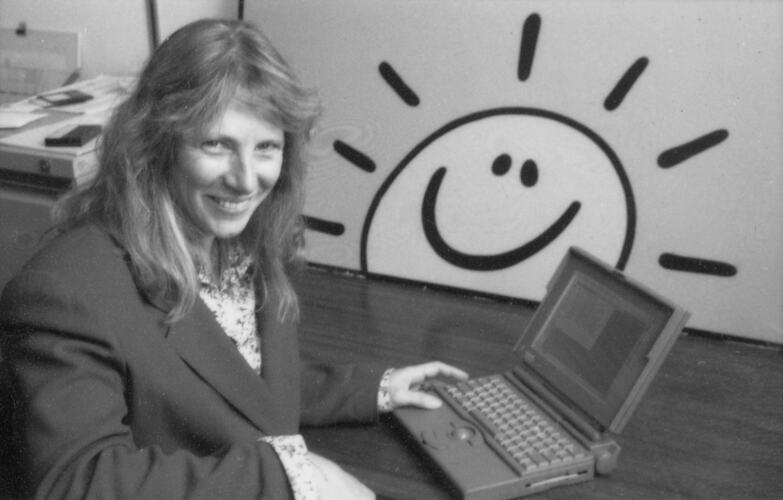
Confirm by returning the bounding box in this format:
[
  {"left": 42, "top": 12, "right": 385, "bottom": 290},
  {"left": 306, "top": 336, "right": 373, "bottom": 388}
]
[{"left": 361, "top": 108, "right": 635, "bottom": 300}]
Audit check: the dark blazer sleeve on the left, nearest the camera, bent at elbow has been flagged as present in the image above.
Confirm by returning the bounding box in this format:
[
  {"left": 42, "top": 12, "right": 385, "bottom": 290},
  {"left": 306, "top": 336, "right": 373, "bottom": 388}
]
[{"left": 0, "top": 272, "right": 290, "bottom": 500}]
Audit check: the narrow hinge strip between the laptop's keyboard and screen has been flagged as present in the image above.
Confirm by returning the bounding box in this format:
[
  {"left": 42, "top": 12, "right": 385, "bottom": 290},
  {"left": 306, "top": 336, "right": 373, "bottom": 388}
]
[{"left": 508, "top": 366, "right": 604, "bottom": 442}]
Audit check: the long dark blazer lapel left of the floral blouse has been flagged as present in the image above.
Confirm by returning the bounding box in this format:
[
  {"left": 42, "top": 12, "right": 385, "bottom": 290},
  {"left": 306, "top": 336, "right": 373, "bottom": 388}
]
[{"left": 168, "top": 299, "right": 287, "bottom": 433}]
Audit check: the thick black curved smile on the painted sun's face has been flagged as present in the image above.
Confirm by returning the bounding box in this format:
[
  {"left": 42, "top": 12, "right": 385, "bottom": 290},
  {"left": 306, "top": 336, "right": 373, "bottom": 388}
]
[{"left": 421, "top": 167, "right": 581, "bottom": 271}]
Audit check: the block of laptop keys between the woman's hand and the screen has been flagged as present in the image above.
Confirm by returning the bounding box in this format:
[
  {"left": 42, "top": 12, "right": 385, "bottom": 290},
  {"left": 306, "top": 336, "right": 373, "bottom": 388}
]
[{"left": 445, "top": 375, "right": 588, "bottom": 473}]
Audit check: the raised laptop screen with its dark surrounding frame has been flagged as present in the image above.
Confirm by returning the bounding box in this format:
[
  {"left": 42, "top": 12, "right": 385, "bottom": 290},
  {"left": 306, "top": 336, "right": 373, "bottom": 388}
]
[{"left": 518, "top": 250, "right": 682, "bottom": 428}]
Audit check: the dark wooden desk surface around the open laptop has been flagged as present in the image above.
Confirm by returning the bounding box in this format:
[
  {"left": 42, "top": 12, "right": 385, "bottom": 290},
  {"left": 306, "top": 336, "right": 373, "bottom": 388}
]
[{"left": 297, "top": 269, "right": 783, "bottom": 500}]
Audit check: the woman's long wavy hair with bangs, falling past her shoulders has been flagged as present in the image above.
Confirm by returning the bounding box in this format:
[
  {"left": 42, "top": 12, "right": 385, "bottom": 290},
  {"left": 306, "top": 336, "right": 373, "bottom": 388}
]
[{"left": 55, "top": 20, "right": 320, "bottom": 322}]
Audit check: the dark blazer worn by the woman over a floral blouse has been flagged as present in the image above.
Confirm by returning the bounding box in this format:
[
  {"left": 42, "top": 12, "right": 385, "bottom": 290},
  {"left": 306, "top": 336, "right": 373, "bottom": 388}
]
[{"left": 0, "top": 226, "right": 381, "bottom": 499}]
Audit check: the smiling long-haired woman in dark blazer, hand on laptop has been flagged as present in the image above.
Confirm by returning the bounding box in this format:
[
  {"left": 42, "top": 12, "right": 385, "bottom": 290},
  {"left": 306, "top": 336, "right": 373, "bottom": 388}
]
[{"left": 0, "top": 20, "right": 466, "bottom": 499}]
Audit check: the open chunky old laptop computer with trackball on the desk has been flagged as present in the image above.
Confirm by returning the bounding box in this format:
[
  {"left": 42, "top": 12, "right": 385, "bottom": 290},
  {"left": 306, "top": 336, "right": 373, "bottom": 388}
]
[{"left": 394, "top": 247, "right": 689, "bottom": 500}]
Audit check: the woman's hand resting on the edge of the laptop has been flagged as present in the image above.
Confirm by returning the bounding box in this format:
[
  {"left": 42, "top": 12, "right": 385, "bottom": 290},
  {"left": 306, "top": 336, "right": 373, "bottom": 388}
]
[{"left": 388, "top": 361, "right": 468, "bottom": 410}]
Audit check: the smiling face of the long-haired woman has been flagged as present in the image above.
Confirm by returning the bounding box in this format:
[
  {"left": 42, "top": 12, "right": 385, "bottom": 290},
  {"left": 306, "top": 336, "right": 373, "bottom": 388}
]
[{"left": 172, "top": 102, "right": 284, "bottom": 251}]
